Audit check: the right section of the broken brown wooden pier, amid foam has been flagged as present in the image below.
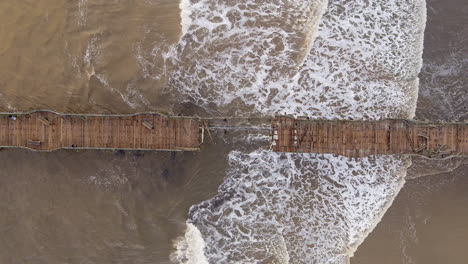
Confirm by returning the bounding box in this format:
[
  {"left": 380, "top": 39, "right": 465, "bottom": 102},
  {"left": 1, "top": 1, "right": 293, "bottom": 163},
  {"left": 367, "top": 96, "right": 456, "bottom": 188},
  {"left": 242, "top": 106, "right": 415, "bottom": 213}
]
[{"left": 272, "top": 117, "right": 468, "bottom": 158}]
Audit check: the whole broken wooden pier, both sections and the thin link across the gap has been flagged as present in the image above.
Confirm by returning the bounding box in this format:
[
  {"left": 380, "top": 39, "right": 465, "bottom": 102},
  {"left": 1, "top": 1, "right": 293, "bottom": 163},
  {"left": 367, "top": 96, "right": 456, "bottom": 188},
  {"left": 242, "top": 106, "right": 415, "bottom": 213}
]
[{"left": 0, "top": 111, "right": 468, "bottom": 158}]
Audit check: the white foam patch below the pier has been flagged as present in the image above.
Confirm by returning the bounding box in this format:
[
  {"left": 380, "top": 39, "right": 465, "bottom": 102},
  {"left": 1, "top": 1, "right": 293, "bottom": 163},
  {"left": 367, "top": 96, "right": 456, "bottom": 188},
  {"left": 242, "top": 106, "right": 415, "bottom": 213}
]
[{"left": 190, "top": 150, "right": 409, "bottom": 263}]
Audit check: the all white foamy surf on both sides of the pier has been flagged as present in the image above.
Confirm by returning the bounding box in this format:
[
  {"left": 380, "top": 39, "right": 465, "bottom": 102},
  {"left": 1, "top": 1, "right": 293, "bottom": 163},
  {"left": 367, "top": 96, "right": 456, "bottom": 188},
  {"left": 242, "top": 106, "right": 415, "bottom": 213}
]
[{"left": 170, "top": 0, "right": 426, "bottom": 263}]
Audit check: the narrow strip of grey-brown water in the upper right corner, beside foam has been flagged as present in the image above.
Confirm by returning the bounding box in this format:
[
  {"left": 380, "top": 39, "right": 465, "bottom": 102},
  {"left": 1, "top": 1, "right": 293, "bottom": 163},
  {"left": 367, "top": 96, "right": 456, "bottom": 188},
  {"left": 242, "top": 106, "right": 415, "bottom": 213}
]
[{"left": 417, "top": 0, "right": 468, "bottom": 122}]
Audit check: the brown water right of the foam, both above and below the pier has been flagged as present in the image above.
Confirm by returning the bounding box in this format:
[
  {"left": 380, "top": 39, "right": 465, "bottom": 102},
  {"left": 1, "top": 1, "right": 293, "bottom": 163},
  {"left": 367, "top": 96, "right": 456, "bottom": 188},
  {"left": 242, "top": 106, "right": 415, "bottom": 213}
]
[{"left": 351, "top": 0, "right": 468, "bottom": 264}]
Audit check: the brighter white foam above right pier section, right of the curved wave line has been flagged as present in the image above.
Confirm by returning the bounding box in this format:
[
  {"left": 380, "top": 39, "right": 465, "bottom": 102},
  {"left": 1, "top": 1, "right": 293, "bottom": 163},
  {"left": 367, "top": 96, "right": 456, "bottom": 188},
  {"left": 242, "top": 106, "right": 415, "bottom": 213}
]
[{"left": 259, "top": 1, "right": 425, "bottom": 119}]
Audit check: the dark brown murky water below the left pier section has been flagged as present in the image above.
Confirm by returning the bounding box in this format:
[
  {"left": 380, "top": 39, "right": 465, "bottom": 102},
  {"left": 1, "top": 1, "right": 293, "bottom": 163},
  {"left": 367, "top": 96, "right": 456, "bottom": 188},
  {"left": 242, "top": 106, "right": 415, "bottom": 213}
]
[{"left": 0, "top": 133, "right": 238, "bottom": 263}]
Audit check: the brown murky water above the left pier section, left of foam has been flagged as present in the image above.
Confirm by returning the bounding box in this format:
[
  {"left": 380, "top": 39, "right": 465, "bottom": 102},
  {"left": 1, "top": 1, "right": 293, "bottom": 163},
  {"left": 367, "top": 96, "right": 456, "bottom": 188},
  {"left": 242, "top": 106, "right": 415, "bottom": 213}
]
[{"left": 0, "top": 0, "right": 181, "bottom": 113}]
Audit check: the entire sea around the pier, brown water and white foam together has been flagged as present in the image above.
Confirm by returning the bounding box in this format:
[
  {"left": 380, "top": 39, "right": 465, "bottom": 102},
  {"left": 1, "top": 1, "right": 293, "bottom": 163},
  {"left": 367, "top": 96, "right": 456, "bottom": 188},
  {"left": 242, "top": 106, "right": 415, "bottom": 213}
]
[{"left": 0, "top": 0, "right": 468, "bottom": 264}]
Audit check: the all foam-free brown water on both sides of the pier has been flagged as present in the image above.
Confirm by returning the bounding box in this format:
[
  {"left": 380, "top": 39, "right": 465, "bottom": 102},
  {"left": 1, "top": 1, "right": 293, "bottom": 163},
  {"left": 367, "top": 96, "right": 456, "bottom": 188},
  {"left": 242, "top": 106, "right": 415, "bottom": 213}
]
[{"left": 0, "top": 0, "right": 468, "bottom": 264}]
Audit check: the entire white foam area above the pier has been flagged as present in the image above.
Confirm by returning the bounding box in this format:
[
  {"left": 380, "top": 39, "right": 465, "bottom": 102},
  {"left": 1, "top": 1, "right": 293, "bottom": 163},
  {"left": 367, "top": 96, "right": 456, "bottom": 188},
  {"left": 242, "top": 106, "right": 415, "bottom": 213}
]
[{"left": 173, "top": 0, "right": 426, "bottom": 119}]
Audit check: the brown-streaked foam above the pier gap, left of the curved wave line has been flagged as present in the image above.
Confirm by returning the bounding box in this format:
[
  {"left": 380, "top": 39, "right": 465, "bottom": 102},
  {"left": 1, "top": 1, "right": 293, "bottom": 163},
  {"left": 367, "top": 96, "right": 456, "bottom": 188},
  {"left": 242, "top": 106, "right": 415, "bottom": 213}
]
[{"left": 171, "top": 0, "right": 326, "bottom": 112}]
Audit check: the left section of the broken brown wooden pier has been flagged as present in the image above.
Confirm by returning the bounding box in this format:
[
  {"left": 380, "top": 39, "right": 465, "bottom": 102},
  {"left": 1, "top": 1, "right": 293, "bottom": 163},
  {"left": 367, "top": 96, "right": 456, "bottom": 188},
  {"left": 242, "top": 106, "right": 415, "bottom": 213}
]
[{"left": 0, "top": 111, "right": 203, "bottom": 151}]
